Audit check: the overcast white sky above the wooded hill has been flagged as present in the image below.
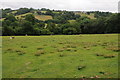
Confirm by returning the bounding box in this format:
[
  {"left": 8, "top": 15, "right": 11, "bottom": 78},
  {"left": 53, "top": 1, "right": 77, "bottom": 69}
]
[{"left": 0, "top": 0, "right": 119, "bottom": 12}]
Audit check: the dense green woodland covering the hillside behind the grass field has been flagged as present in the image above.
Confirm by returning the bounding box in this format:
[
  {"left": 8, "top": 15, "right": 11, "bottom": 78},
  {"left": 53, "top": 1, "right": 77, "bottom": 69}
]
[{"left": 0, "top": 8, "right": 120, "bottom": 36}]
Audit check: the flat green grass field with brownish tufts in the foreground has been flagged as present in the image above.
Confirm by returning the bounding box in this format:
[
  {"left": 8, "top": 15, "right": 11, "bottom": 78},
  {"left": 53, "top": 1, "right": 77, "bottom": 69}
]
[{"left": 2, "top": 34, "right": 119, "bottom": 78}]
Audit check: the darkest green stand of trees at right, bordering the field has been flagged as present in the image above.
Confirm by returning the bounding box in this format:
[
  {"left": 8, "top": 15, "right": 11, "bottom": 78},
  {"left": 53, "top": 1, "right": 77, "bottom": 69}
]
[{"left": 81, "top": 14, "right": 120, "bottom": 34}]
